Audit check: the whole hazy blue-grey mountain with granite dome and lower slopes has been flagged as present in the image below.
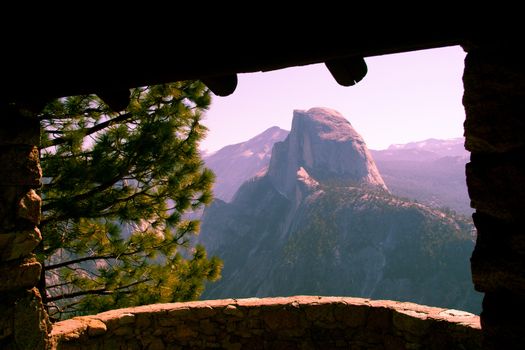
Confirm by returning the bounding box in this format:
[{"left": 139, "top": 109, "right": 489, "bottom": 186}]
[{"left": 199, "top": 108, "right": 480, "bottom": 312}]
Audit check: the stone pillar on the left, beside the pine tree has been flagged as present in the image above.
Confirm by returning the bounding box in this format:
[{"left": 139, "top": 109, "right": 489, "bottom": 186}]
[{"left": 0, "top": 105, "right": 50, "bottom": 349}]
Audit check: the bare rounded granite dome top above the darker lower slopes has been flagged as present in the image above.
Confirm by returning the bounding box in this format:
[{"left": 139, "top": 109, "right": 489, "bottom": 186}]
[{"left": 268, "top": 107, "right": 386, "bottom": 198}]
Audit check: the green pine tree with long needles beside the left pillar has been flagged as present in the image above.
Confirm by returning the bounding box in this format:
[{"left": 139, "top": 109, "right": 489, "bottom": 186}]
[{"left": 38, "top": 81, "right": 222, "bottom": 318}]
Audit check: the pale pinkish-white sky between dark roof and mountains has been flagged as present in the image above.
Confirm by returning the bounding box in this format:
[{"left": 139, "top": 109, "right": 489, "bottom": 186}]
[{"left": 201, "top": 46, "right": 465, "bottom": 152}]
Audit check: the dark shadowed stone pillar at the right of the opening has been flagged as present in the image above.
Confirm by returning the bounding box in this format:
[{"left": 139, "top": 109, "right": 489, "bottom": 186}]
[{"left": 463, "top": 45, "right": 525, "bottom": 349}]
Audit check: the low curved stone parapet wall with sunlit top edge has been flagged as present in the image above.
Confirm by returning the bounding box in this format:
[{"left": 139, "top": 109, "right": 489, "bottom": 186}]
[{"left": 51, "top": 296, "right": 481, "bottom": 350}]
